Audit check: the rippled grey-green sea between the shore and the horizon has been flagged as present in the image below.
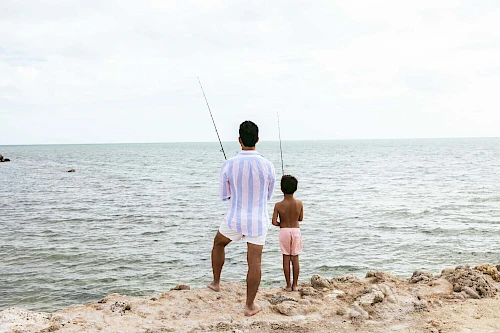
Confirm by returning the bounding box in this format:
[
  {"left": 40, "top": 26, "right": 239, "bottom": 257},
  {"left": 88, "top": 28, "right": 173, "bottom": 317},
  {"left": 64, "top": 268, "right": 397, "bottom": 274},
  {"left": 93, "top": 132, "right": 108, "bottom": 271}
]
[{"left": 0, "top": 138, "right": 500, "bottom": 311}]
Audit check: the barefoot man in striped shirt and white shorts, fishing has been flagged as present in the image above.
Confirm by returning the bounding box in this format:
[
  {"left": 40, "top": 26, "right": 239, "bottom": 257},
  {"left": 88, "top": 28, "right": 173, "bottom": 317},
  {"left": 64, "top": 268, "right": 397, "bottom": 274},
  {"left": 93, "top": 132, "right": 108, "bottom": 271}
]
[{"left": 208, "top": 120, "right": 276, "bottom": 316}]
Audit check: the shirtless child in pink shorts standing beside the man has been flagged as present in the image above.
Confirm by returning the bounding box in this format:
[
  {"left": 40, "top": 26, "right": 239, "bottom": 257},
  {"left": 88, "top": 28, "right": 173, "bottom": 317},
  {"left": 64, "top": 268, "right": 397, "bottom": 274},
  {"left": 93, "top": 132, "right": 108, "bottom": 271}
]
[{"left": 273, "top": 175, "right": 304, "bottom": 291}]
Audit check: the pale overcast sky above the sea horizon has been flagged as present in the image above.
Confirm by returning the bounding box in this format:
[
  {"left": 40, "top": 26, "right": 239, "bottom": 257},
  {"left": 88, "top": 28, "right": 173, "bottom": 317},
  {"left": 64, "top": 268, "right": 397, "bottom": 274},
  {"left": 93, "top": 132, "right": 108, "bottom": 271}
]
[{"left": 0, "top": 0, "right": 500, "bottom": 145}]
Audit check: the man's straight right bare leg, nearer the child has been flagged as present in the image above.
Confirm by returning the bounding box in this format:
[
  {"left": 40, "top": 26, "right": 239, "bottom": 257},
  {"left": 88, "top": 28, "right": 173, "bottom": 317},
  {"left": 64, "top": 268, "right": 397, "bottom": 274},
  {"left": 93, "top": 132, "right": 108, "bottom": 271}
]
[{"left": 245, "top": 243, "right": 264, "bottom": 317}]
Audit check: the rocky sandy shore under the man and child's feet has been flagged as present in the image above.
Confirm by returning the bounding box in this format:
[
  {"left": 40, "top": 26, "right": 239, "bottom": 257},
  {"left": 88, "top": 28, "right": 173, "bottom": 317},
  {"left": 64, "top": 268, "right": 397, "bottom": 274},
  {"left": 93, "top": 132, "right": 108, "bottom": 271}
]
[{"left": 0, "top": 265, "right": 500, "bottom": 333}]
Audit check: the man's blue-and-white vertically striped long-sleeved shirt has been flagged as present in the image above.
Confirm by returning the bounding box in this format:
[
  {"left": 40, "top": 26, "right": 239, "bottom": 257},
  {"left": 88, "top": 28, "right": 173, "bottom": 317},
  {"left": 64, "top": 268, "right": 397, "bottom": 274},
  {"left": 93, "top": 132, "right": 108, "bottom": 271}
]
[{"left": 220, "top": 150, "right": 276, "bottom": 237}]
